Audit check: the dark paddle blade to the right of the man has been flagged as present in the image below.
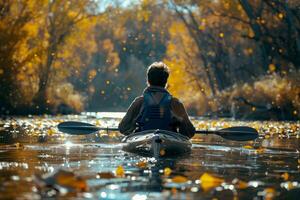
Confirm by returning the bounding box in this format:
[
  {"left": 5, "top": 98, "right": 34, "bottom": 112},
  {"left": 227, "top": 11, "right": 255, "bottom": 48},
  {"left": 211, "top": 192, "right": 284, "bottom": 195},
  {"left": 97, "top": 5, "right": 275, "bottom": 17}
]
[{"left": 216, "top": 126, "right": 258, "bottom": 141}]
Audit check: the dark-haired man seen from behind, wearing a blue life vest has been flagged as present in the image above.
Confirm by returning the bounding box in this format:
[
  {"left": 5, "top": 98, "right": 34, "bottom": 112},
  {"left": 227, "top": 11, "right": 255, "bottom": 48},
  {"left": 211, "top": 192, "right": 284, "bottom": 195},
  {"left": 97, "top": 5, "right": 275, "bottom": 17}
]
[{"left": 119, "top": 62, "right": 195, "bottom": 138}]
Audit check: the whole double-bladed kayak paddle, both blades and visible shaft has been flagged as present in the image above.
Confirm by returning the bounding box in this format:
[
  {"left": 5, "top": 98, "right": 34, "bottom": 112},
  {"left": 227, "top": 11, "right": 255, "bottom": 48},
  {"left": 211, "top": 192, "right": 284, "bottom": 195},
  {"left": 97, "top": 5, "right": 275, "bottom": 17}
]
[{"left": 57, "top": 121, "right": 258, "bottom": 141}]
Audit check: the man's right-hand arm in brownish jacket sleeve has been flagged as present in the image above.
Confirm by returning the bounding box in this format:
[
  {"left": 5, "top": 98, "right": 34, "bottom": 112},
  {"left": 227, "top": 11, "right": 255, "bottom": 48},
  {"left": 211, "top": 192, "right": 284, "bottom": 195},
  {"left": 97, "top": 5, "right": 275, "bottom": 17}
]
[{"left": 171, "top": 98, "right": 195, "bottom": 138}]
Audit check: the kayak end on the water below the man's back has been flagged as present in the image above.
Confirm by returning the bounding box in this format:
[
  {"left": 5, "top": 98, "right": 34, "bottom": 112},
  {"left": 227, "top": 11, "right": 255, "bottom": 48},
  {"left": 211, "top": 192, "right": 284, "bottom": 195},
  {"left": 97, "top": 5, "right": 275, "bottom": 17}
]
[{"left": 122, "top": 129, "right": 192, "bottom": 158}]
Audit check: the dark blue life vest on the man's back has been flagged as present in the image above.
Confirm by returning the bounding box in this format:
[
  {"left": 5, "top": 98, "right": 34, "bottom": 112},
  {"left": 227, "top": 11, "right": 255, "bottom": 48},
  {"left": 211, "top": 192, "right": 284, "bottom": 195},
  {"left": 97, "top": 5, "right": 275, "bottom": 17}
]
[{"left": 137, "top": 89, "right": 172, "bottom": 131}]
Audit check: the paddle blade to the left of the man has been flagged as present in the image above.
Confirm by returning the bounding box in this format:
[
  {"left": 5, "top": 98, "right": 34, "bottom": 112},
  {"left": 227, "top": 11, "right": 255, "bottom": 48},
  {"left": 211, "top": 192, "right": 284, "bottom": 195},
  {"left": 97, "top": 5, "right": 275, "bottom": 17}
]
[{"left": 57, "top": 121, "right": 99, "bottom": 135}]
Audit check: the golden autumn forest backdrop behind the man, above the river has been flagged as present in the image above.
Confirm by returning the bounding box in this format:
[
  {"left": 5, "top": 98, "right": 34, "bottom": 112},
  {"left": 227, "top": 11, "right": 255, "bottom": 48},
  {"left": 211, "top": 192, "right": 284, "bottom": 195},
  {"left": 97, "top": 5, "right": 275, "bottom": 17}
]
[{"left": 0, "top": 0, "right": 300, "bottom": 120}]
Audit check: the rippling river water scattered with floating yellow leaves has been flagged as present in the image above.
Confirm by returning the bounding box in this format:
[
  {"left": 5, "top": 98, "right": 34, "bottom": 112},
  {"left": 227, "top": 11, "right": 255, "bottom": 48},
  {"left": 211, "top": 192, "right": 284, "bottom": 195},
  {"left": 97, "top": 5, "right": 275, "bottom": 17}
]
[{"left": 0, "top": 113, "right": 300, "bottom": 199}]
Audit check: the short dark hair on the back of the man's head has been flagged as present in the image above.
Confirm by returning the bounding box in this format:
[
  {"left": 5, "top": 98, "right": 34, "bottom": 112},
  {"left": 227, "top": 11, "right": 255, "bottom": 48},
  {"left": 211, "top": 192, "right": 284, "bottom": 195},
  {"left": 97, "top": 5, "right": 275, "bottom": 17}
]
[{"left": 147, "top": 62, "right": 169, "bottom": 87}]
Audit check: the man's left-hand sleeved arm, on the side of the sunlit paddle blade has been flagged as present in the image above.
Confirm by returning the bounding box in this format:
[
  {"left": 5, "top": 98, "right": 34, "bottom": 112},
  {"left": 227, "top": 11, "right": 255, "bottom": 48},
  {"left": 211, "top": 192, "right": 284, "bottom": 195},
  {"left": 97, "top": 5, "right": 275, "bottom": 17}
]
[{"left": 118, "top": 97, "right": 143, "bottom": 135}]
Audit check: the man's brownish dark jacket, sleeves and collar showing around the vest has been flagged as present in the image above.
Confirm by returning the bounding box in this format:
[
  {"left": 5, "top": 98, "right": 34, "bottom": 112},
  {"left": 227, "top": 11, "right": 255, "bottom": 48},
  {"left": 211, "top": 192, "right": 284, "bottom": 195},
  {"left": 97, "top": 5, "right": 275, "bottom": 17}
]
[{"left": 119, "top": 86, "right": 195, "bottom": 138}]
